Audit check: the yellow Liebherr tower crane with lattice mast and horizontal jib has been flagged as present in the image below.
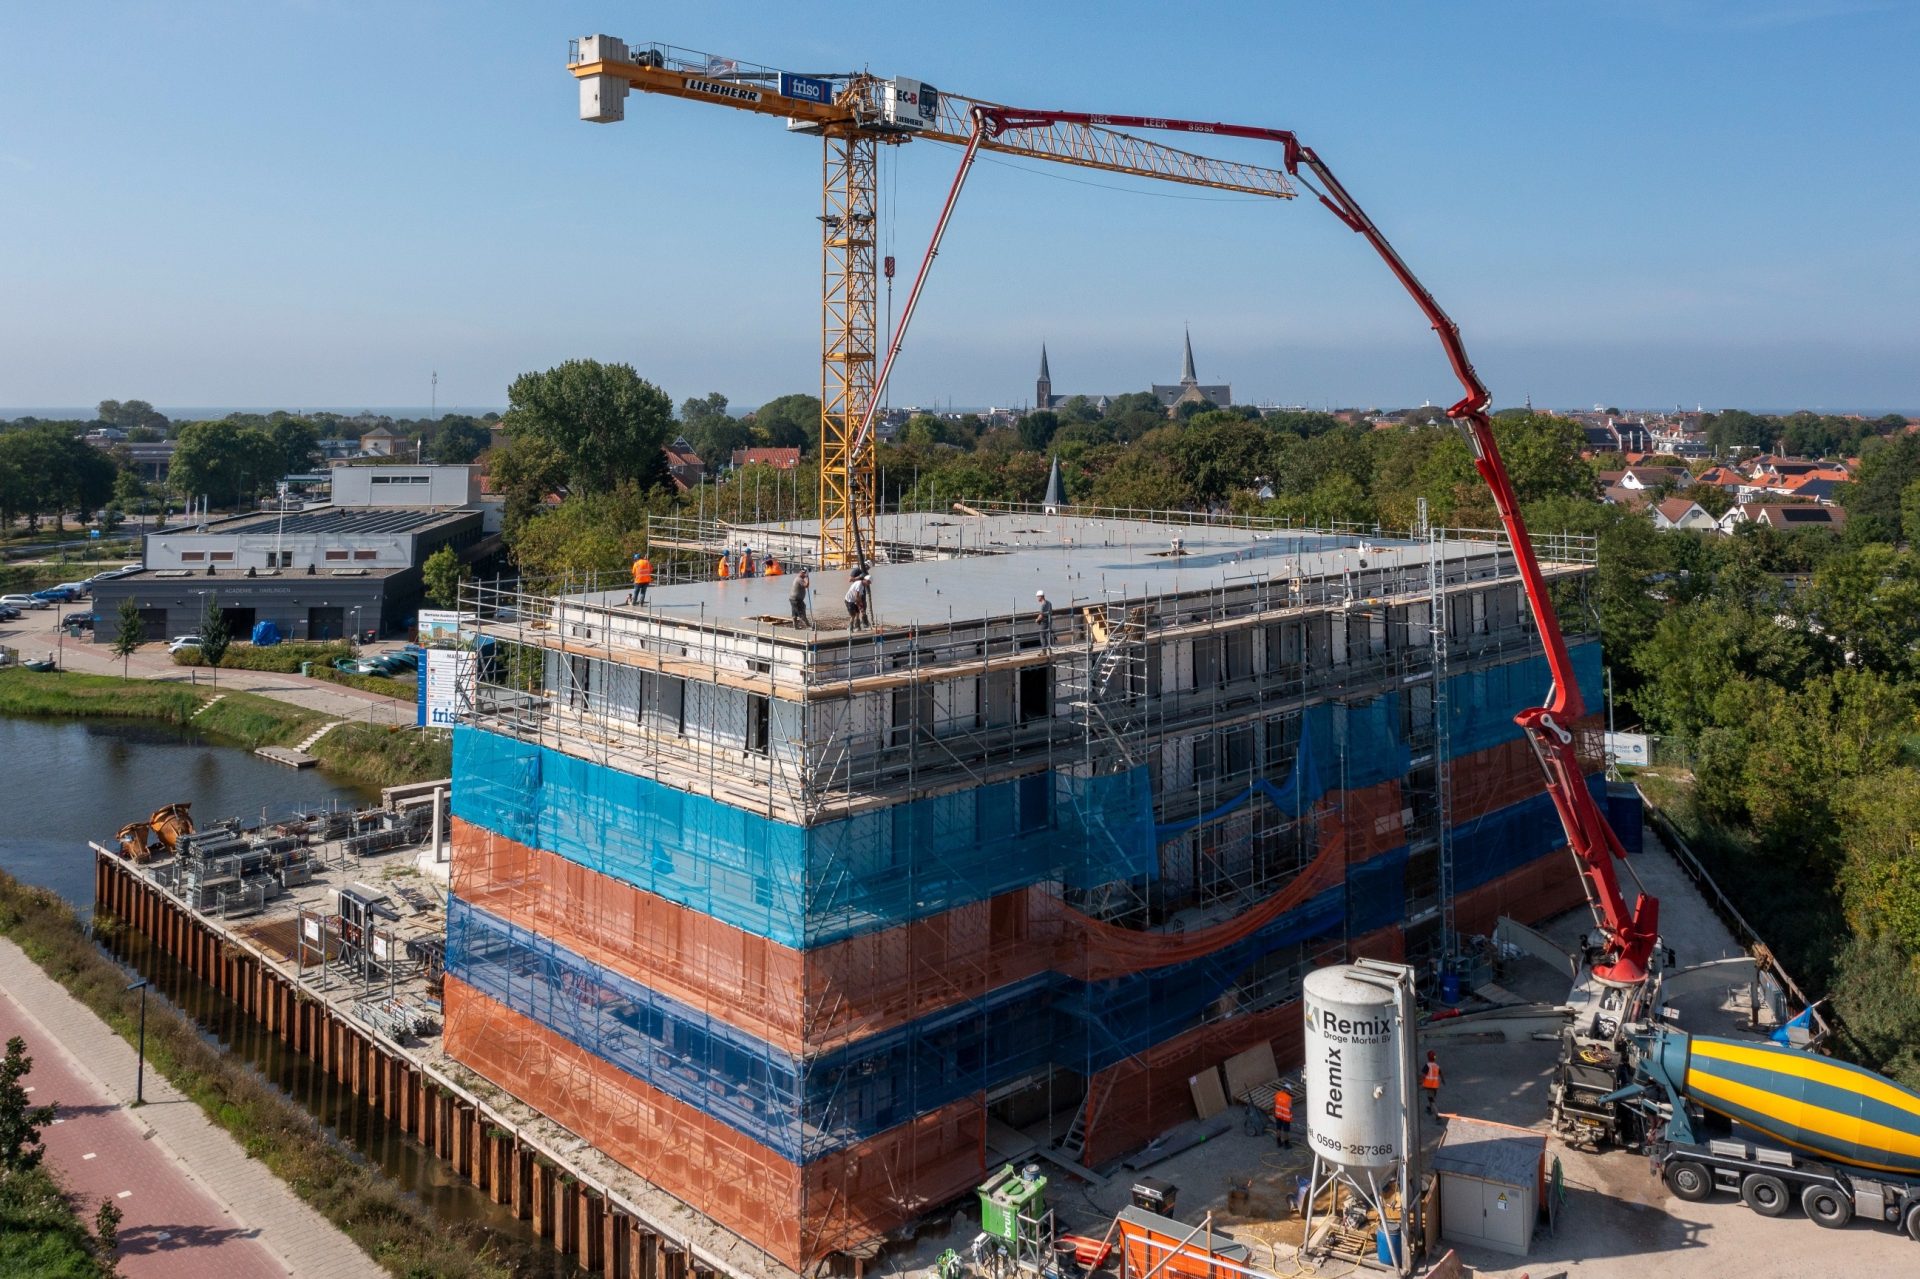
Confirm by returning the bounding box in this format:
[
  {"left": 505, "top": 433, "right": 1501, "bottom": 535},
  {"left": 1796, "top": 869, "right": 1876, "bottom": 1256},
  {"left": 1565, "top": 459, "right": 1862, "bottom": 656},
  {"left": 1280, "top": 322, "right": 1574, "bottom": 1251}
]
[{"left": 568, "top": 35, "right": 1294, "bottom": 567}]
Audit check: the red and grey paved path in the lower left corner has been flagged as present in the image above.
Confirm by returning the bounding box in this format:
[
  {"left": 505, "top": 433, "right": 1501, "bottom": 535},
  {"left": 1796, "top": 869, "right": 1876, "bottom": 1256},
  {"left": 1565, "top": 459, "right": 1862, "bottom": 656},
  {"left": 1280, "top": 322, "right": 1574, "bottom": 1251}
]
[{"left": 0, "top": 941, "right": 386, "bottom": 1279}]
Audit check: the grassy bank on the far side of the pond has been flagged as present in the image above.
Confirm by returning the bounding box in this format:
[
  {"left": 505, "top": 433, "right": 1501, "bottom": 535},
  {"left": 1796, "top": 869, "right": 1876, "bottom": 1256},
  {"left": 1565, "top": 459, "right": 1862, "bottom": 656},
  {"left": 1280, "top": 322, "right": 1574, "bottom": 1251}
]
[{"left": 0, "top": 668, "right": 453, "bottom": 785}]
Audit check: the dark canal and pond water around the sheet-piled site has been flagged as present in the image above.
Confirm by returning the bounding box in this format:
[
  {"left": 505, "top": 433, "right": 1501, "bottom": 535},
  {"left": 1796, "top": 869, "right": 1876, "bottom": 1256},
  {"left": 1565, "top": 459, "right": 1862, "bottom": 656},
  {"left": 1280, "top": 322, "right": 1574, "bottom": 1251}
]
[{"left": 0, "top": 716, "right": 580, "bottom": 1275}]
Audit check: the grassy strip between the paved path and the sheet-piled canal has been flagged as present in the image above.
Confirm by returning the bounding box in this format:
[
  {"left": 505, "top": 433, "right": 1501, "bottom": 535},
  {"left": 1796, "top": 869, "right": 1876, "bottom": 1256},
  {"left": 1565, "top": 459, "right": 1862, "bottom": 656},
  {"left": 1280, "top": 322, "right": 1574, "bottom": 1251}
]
[{"left": 0, "top": 874, "right": 522, "bottom": 1279}]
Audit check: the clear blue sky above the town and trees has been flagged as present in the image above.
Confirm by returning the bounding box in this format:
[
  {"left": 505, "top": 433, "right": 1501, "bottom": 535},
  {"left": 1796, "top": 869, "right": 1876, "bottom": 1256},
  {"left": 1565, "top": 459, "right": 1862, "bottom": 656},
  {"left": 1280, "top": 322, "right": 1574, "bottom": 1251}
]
[{"left": 0, "top": 0, "right": 1920, "bottom": 411}]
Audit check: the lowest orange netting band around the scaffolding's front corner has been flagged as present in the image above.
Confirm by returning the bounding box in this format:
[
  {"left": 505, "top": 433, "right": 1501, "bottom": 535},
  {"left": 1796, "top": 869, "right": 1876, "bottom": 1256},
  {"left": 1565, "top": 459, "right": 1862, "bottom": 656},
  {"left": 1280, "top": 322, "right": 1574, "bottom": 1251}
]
[{"left": 445, "top": 976, "right": 987, "bottom": 1271}]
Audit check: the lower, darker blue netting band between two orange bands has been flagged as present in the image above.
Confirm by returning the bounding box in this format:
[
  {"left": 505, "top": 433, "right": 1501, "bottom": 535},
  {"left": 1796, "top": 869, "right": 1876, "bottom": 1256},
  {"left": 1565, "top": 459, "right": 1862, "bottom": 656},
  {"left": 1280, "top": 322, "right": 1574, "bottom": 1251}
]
[{"left": 447, "top": 871, "right": 1344, "bottom": 1162}]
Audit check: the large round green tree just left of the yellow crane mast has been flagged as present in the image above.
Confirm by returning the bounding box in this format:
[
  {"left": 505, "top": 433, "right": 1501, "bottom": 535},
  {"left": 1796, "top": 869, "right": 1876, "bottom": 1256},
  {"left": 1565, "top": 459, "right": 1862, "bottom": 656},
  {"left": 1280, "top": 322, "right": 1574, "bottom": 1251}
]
[{"left": 501, "top": 359, "right": 672, "bottom": 494}]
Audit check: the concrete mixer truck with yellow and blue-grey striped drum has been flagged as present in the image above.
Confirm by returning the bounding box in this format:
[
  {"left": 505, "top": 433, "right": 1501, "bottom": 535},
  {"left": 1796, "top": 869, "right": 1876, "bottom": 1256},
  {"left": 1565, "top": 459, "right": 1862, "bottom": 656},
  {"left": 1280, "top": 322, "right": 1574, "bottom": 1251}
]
[{"left": 1617, "top": 1027, "right": 1920, "bottom": 1241}]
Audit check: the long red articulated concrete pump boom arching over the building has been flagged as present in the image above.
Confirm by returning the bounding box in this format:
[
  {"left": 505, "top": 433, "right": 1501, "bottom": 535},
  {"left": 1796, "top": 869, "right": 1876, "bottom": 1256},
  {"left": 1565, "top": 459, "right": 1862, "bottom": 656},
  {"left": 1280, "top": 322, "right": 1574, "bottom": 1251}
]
[{"left": 879, "top": 104, "right": 1659, "bottom": 985}]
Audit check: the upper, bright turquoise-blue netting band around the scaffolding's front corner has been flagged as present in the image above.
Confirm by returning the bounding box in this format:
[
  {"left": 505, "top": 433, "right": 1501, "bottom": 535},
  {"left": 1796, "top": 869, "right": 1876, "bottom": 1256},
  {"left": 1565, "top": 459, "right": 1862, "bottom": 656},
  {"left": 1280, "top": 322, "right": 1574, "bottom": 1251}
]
[{"left": 453, "top": 726, "right": 1158, "bottom": 949}]
